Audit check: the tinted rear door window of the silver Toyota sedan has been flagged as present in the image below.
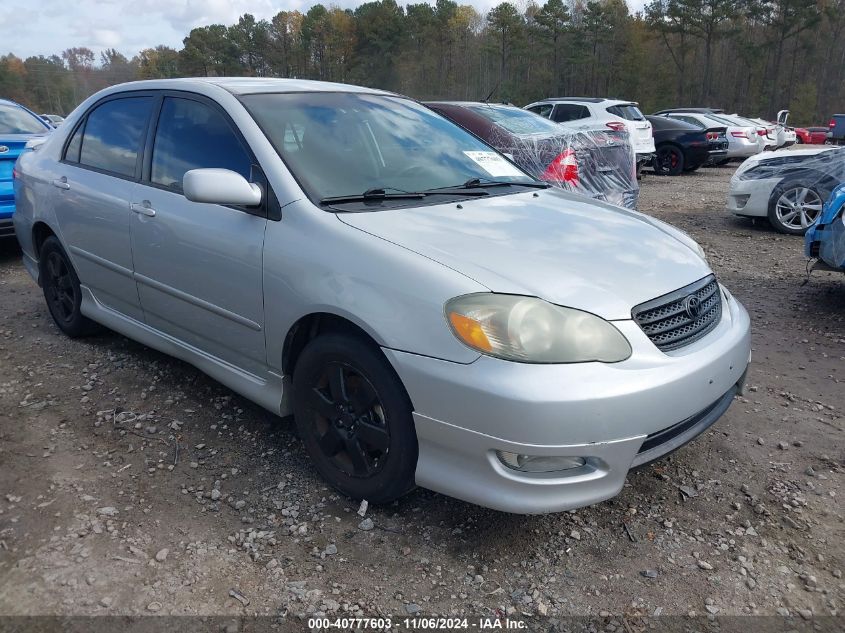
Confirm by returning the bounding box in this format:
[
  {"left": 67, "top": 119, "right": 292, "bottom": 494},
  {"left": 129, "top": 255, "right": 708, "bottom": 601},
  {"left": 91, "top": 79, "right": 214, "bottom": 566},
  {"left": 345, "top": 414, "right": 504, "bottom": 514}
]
[{"left": 78, "top": 96, "right": 153, "bottom": 178}]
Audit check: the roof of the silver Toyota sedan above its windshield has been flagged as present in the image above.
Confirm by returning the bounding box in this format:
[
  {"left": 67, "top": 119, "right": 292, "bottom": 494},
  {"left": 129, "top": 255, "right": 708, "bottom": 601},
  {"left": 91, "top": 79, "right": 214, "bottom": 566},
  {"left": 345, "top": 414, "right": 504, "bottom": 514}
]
[{"left": 97, "top": 77, "right": 394, "bottom": 95}]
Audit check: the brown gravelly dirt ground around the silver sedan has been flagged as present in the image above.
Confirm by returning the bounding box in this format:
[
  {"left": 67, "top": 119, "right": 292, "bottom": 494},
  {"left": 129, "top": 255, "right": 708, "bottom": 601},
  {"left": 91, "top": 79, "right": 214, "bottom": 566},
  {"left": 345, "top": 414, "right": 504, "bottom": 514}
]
[{"left": 0, "top": 168, "right": 845, "bottom": 630}]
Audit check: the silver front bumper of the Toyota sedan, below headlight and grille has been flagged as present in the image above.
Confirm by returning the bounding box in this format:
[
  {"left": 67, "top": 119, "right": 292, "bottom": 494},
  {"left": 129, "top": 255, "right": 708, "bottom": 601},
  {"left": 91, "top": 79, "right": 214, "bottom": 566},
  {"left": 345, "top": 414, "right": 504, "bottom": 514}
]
[{"left": 385, "top": 288, "right": 751, "bottom": 514}]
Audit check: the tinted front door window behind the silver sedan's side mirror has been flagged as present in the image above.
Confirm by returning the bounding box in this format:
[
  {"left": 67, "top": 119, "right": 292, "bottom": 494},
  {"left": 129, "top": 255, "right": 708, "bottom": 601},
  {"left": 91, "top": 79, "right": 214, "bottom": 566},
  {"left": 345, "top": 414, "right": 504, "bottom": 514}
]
[{"left": 150, "top": 97, "right": 252, "bottom": 193}]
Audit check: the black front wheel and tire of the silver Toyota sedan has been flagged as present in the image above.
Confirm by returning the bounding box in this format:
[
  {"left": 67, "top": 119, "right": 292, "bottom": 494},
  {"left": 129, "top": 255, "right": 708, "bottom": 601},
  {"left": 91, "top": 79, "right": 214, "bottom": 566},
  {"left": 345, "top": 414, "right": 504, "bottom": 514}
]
[{"left": 293, "top": 333, "right": 418, "bottom": 504}]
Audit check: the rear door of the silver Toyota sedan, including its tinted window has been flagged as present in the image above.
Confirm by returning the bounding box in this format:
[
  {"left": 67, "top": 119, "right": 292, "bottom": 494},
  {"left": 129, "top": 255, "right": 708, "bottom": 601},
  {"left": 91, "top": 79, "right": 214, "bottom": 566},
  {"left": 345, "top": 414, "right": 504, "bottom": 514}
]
[{"left": 51, "top": 93, "right": 155, "bottom": 321}]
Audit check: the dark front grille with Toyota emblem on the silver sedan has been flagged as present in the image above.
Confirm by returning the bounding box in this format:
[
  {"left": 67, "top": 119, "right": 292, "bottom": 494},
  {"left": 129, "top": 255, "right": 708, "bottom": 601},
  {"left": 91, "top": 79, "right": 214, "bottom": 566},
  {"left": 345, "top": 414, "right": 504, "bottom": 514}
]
[{"left": 631, "top": 275, "right": 722, "bottom": 352}]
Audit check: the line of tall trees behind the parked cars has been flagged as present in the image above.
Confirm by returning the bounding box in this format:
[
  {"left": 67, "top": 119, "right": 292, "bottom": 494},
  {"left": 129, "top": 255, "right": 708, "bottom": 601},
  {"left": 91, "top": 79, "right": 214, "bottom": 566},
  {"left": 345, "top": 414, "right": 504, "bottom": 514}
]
[{"left": 0, "top": 0, "right": 845, "bottom": 125}]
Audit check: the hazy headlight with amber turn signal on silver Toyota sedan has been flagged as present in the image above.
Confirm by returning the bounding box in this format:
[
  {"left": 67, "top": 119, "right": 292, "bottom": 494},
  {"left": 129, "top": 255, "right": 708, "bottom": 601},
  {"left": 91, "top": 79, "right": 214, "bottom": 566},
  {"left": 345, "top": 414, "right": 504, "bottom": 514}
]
[{"left": 446, "top": 293, "right": 631, "bottom": 363}]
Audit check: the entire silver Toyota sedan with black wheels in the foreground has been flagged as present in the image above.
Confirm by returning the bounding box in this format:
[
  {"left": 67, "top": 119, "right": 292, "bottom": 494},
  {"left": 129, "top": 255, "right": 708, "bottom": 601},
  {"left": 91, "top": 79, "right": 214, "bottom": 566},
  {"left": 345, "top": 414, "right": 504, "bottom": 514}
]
[{"left": 15, "top": 78, "right": 750, "bottom": 513}]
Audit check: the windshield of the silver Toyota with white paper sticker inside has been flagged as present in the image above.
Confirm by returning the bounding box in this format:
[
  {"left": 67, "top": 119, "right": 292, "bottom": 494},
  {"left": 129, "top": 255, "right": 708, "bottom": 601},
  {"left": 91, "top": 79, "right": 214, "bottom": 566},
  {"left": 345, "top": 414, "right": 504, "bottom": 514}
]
[{"left": 242, "top": 92, "right": 535, "bottom": 200}]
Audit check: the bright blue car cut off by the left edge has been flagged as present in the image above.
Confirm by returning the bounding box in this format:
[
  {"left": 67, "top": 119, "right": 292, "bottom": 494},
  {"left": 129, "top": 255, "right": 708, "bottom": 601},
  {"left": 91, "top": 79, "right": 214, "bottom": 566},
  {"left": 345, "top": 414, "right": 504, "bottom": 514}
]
[{"left": 0, "top": 99, "right": 53, "bottom": 237}]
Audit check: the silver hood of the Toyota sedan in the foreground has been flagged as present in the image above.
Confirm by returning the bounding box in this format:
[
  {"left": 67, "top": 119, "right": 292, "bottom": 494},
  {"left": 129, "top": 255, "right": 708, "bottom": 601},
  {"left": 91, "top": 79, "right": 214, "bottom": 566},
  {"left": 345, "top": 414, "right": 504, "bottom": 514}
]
[{"left": 337, "top": 189, "right": 710, "bottom": 320}]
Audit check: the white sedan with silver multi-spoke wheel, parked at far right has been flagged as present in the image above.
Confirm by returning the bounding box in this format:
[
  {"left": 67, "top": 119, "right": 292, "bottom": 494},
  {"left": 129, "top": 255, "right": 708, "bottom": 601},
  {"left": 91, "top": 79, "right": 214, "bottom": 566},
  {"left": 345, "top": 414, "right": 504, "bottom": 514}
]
[{"left": 727, "top": 147, "right": 845, "bottom": 235}]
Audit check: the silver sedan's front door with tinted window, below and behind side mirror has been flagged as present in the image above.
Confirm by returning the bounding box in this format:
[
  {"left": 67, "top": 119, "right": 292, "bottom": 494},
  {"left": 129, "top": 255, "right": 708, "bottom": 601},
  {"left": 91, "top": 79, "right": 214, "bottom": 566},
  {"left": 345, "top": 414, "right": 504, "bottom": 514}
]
[{"left": 131, "top": 95, "right": 267, "bottom": 372}]
